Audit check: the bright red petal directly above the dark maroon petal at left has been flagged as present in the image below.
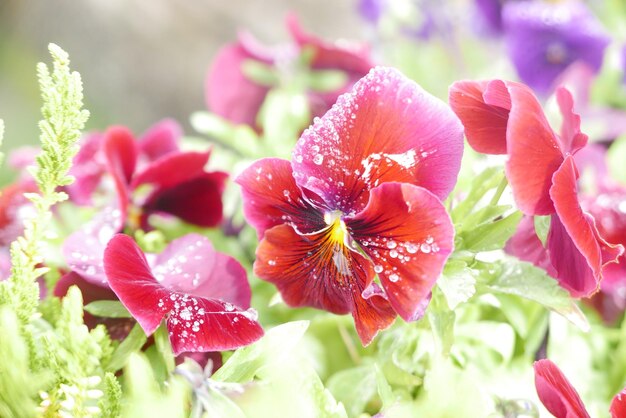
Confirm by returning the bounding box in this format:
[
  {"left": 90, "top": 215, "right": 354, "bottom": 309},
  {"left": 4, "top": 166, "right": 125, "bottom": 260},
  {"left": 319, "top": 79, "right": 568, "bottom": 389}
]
[{"left": 132, "top": 151, "right": 211, "bottom": 188}]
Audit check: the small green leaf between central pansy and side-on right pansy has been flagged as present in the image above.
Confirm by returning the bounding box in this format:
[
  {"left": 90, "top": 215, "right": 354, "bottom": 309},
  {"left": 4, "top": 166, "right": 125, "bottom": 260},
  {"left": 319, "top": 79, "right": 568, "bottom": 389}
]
[{"left": 459, "top": 211, "right": 522, "bottom": 253}]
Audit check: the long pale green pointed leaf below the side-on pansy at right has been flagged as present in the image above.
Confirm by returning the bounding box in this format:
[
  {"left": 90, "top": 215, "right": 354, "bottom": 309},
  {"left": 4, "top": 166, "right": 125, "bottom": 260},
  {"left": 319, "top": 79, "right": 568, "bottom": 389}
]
[{"left": 487, "top": 257, "right": 589, "bottom": 330}]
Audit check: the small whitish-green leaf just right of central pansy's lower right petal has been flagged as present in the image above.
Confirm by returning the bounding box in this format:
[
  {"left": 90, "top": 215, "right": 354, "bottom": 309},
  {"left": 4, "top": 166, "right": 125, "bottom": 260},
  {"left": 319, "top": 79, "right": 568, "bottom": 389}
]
[{"left": 437, "top": 260, "right": 476, "bottom": 310}]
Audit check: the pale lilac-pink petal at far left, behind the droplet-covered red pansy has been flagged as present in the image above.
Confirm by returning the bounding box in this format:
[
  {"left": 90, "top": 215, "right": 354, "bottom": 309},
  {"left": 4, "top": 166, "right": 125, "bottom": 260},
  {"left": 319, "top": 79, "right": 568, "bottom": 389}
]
[{"left": 62, "top": 208, "right": 124, "bottom": 286}]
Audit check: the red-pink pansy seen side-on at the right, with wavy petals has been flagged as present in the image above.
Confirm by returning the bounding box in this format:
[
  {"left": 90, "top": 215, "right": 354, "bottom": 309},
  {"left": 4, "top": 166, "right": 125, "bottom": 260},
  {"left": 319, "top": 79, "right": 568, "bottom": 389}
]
[{"left": 450, "top": 80, "right": 623, "bottom": 297}]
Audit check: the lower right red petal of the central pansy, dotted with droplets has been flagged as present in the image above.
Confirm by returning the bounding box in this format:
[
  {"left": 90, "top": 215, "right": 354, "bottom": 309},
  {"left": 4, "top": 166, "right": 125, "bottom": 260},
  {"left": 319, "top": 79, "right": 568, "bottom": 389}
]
[{"left": 346, "top": 183, "right": 454, "bottom": 321}]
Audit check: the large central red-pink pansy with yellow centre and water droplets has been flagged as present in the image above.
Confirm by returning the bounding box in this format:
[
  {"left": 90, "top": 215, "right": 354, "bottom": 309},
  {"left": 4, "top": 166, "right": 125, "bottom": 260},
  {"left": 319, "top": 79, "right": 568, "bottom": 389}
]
[{"left": 236, "top": 67, "right": 463, "bottom": 344}]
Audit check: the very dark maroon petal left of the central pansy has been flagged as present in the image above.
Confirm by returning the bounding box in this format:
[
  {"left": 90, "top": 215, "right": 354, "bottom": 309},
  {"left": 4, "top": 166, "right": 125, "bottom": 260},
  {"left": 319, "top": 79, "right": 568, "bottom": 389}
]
[{"left": 142, "top": 171, "right": 228, "bottom": 227}]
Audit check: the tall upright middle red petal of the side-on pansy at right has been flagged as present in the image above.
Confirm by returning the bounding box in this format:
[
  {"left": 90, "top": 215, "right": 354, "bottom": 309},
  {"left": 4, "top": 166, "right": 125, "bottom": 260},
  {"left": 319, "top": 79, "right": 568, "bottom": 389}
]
[{"left": 506, "top": 83, "right": 563, "bottom": 216}]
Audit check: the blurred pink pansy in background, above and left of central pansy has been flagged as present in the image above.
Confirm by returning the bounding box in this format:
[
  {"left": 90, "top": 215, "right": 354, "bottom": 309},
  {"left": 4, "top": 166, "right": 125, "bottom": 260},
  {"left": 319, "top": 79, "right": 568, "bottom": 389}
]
[{"left": 205, "top": 15, "right": 372, "bottom": 127}]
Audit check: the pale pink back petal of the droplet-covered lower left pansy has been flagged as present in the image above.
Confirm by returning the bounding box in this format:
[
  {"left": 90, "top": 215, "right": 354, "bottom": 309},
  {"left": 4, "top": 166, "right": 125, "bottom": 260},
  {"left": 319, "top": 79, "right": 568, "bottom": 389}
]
[{"left": 151, "top": 234, "right": 250, "bottom": 309}]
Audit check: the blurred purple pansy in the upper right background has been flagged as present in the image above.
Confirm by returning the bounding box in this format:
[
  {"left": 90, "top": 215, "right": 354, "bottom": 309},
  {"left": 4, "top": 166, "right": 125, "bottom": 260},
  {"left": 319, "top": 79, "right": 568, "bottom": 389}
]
[{"left": 502, "top": 0, "right": 610, "bottom": 93}]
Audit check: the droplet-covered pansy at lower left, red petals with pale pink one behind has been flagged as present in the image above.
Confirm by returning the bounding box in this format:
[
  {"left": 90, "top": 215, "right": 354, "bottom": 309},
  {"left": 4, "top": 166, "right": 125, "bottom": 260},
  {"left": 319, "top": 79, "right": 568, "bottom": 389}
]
[{"left": 104, "top": 234, "right": 263, "bottom": 355}]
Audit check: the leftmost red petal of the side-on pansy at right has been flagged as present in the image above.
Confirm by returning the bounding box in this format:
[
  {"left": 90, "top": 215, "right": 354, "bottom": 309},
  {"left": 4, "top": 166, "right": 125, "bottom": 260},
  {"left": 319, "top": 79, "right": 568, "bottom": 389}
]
[{"left": 449, "top": 80, "right": 511, "bottom": 154}]
